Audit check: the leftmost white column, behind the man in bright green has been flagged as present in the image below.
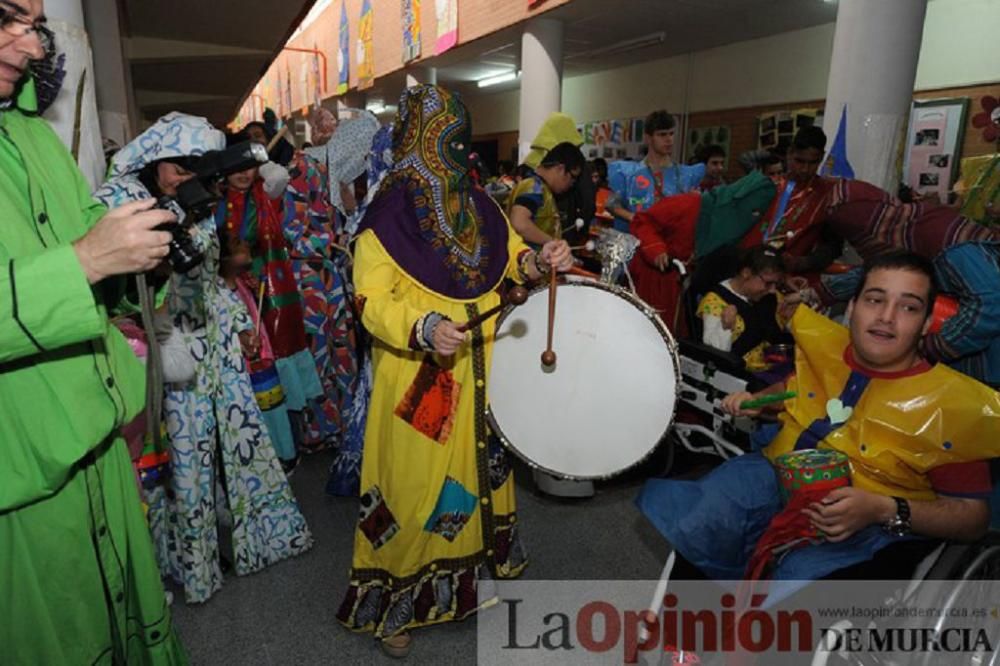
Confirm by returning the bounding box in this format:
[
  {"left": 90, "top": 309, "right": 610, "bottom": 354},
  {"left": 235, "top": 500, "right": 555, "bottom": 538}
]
[{"left": 44, "top": 0, "right": 105, "bottom": 189}]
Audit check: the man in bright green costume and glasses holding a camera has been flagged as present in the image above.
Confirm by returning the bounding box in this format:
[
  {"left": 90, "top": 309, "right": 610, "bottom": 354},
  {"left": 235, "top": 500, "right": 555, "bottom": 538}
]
[{"left": 0, "top": 0, "right": 187, "bottom": 665}]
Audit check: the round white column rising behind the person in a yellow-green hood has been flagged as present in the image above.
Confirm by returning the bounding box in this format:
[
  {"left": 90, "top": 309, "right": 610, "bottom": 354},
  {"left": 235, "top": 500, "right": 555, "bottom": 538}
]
[{"left": 518, "top": 18, "right": 563, "bottom": 160}]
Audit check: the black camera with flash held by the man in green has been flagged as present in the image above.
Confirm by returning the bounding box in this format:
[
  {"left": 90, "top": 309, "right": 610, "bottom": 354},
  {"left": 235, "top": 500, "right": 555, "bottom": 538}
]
[{"left": 156, "top": 141, "right": 267, "bottom": 273}]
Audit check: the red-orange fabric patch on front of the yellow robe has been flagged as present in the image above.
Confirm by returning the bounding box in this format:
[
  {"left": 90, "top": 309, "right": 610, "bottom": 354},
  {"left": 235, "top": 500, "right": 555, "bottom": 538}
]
[{"left": 394, "top": 356, "right": 462, "bottom": 444}]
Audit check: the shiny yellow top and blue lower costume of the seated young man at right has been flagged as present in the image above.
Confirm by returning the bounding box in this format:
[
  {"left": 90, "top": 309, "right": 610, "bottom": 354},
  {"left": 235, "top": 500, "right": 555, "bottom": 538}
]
[{"left": 637, "top": 307, "right": 1000, "bottom": 581}]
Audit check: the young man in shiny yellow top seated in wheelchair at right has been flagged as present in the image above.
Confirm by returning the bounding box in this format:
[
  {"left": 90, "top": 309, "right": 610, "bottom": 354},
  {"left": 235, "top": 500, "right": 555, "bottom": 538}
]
[{"left": 637, "top": 252, "right": 1000, "bottom": 580}]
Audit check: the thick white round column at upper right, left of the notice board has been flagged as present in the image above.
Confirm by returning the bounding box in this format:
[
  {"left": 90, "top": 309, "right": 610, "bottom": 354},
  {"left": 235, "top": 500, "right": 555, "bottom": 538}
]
[{"left": 823, "top": 0, "right": 927, "bottom": 192}]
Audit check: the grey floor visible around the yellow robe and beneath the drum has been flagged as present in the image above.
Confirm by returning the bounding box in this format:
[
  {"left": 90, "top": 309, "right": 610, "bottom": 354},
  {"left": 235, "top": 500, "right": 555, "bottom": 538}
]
[{"left": 173, "top": 453, "right": 668, "bottom": 666}]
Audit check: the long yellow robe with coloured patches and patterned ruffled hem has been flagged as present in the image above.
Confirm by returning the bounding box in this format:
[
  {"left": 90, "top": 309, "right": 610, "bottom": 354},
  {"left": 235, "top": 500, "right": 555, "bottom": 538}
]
[{"left": 338, "top": 224, "right": 529, "bottom": 638}]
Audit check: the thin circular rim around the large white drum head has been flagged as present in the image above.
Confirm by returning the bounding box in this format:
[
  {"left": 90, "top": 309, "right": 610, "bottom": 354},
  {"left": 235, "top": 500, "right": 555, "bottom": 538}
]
[{"left": 486, "top": 278, "right": 681, "bottom": 481}]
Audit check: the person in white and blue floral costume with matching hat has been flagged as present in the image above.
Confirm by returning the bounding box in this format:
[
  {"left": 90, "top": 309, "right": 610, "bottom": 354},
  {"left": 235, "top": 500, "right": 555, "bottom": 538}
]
[{"left": 97, "top": 113, "right": 312, "bottom": 603}]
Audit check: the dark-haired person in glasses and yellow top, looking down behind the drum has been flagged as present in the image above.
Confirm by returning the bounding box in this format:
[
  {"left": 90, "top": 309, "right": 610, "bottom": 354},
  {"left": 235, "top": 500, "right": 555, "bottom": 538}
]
[{"left": 507, "top": 142, "right": 587, "bottom": 249}]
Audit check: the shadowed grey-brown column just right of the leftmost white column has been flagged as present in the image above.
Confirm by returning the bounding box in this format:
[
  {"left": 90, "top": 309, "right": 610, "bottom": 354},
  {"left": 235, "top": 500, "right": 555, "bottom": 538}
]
[{"left": 83, "top": 0, "right": 137, "bottom": 146}]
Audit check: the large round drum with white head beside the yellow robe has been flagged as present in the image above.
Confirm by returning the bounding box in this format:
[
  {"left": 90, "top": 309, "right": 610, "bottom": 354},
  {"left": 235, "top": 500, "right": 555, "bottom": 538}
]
[{"left": 489, "top": 278, "right": 680, "bottom": 479}]
